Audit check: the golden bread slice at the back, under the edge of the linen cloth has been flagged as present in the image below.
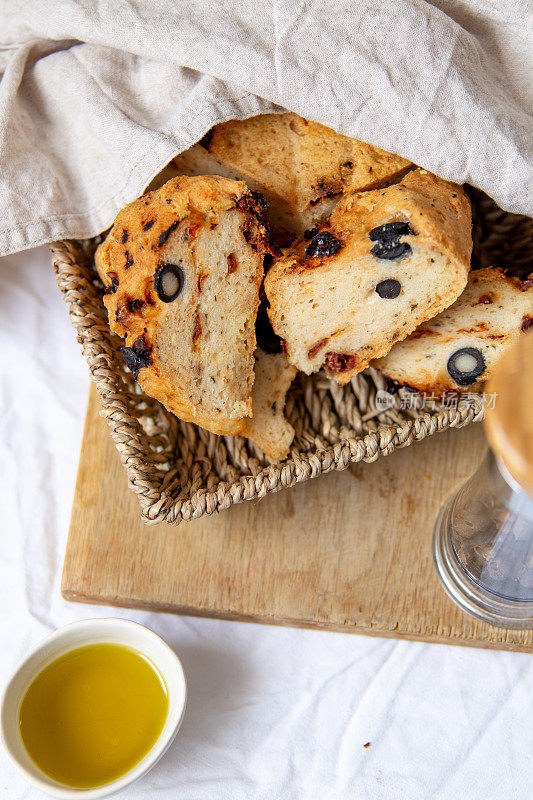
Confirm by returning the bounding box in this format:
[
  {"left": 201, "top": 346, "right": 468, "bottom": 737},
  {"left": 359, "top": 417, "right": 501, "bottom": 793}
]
[{"left": 174, "top": 113, "right": 413, "bottom": 244}]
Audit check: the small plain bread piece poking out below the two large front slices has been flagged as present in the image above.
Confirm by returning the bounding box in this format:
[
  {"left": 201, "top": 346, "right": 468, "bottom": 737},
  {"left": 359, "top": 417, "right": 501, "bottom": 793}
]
[{"left": 243, "top": 348, "right": 296, "bottom": 461}]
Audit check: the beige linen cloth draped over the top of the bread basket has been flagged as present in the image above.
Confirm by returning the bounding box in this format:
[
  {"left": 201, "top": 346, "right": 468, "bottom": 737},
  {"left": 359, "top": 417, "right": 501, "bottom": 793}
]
[{"left": 0, "top": 0, "right": 533, "bottom": 254}]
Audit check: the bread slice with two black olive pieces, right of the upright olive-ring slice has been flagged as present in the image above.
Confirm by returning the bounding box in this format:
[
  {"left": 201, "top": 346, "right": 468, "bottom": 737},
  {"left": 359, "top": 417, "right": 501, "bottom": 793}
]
[{"left": 264, "top": 169, "right": 472, "bottom": 384}]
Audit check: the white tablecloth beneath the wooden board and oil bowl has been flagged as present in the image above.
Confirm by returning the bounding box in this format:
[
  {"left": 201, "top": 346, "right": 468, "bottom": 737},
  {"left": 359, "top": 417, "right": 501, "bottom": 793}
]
[{"left": 0, "top": 249, "right": 533, "bottom": 800}]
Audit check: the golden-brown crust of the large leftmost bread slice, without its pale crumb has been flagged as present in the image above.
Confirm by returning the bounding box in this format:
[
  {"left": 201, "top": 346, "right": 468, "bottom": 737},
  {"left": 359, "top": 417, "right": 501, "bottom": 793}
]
[{"left": 95, "top": 177, "right": 271, "bottom": 435}]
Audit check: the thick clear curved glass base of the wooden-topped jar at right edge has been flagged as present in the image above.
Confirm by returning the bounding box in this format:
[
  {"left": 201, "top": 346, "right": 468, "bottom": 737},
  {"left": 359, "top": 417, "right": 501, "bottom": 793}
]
[{"left": 433, "top": 498, "right": 533, "bottom": 630}]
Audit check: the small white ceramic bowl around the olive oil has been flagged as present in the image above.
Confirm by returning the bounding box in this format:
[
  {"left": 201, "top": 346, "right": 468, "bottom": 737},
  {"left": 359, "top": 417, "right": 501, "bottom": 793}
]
[{"left": 0, "top": 619, "right": 187, "bottom": 800}]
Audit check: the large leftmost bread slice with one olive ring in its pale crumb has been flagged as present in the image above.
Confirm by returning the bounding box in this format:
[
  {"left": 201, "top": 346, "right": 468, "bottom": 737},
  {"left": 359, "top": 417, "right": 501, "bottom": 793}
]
[{"left": 96, "top": 177, "right": 271, "bottom": 435}]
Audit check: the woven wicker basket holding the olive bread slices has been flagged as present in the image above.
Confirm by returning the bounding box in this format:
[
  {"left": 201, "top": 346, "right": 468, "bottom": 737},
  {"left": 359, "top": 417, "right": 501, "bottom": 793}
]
[{"left": 50, "top": 190, "right": 533, "bottom": 524}]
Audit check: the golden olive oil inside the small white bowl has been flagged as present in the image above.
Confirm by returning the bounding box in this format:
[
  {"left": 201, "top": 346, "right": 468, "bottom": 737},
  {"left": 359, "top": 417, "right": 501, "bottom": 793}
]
[{"left": 19, "top": 644, "right": 168, "bottom": 789}]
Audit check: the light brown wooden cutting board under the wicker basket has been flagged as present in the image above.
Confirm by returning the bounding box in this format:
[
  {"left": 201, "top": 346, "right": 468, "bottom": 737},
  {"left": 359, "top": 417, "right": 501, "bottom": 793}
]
[{"left": 62, "top": 389, "right": 533, "bottom": 652}]
